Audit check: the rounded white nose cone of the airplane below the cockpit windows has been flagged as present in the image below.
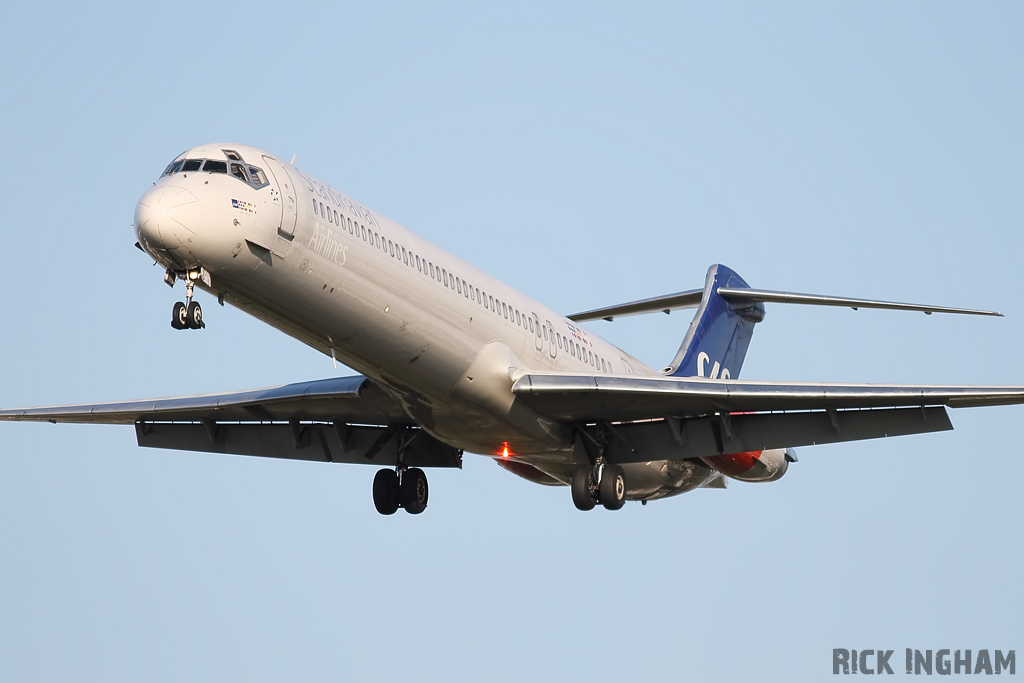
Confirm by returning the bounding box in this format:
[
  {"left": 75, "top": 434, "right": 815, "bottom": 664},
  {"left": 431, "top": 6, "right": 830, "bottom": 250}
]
[{"left": 135, "top": 184, "right": 203, "bottom": 251}]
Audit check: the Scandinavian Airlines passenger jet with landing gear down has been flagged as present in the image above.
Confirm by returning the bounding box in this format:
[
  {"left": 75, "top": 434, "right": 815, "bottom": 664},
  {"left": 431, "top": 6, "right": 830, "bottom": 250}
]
[{"left": 0, "top": 143, "right": 1024, "bottom": 515}]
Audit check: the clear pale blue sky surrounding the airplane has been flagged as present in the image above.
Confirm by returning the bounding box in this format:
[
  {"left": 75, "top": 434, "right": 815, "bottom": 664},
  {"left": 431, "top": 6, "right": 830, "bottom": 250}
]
[{"left": 0, "top": 2, "right": 1024, "bottom": 681}]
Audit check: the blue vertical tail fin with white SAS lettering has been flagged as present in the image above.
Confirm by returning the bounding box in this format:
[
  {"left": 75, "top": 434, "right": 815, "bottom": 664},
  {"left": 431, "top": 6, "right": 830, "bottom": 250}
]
[{"left": 664, "top": 264, "right": 765, "bottom": 380}]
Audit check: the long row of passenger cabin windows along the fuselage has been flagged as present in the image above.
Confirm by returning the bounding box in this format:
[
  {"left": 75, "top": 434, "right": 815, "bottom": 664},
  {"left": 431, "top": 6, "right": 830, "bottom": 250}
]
[{"left": 312, "top": 198, "right": 614, "bottom": 373}]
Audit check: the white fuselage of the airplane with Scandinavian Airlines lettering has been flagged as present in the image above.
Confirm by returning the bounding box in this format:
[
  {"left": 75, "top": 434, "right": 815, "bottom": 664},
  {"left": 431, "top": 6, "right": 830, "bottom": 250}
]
[{"left": 135, "top": 144, "right": 657, "bottom": 469}]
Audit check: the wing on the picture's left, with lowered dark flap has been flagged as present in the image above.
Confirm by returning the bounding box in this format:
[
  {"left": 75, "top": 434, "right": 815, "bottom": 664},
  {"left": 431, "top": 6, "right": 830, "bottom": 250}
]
[{"left": 0, "top": 376, "right": 462, "bottom": 467}]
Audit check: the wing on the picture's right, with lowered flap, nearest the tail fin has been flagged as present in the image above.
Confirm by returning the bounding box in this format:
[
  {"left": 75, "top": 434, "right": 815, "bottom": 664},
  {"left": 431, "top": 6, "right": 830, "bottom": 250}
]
[{"left": 512, "top": 374, "right": 1024, "bottom": 464}]
